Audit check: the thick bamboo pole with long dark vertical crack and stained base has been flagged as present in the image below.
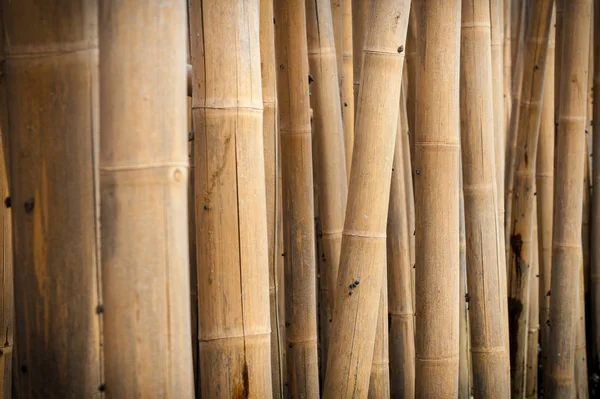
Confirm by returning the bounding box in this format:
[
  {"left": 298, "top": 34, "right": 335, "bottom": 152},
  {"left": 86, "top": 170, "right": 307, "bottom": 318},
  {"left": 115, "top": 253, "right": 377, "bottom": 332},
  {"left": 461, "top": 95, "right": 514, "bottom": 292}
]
[{"left": 191, "top": 0, "right": 274, "bottom": 398}]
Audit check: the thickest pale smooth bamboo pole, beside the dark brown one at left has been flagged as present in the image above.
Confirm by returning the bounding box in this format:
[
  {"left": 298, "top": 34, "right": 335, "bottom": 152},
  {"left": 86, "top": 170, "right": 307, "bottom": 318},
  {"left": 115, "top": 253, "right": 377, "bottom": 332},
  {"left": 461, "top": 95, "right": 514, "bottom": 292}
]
[{"left": 99, "top": 0, "right": 194, "bottom": 398}]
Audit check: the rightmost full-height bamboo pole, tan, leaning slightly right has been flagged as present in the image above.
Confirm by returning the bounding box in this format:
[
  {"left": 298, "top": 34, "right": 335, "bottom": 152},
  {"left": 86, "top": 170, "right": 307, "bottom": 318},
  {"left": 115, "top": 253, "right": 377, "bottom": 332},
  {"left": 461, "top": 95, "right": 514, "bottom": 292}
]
[{"left": 545, "top": 0, "right": 591, "bottom": 398}]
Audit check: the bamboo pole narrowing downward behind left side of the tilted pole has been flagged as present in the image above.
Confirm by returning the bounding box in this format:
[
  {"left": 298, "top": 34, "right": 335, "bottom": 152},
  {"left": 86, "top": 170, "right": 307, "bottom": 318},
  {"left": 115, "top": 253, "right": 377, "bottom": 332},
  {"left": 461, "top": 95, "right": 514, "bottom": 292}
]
[{"left": 306, "top": 0, "right": 348, "bottom": 377}]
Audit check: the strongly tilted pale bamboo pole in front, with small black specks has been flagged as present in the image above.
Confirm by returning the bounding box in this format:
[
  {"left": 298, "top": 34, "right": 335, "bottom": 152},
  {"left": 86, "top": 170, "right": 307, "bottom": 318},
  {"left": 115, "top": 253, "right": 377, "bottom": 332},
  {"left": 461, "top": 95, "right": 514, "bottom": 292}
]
[{"left": 324, "top": 0, "right": 410, "bottom": 398}]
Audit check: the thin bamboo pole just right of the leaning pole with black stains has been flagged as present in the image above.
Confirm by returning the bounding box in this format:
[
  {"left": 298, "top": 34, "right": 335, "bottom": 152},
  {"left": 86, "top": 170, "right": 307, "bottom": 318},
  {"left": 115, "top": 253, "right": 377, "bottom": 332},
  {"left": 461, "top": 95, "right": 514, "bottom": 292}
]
[{"left": 530, "top": 7, "right": 556, "bottom": 381}]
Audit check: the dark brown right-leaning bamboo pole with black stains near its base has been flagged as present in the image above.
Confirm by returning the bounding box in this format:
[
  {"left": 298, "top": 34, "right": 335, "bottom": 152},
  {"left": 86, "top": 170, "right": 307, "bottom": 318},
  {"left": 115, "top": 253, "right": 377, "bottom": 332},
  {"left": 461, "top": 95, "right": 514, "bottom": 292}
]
[{"left": 507, "top": 0, "right": 553, "bottom": 397}]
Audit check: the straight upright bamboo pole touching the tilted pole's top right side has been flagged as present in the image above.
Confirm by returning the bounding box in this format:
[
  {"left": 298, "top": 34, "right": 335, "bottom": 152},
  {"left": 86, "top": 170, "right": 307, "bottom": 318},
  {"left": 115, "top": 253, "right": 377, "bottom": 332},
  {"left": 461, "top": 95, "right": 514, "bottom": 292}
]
[{"left": 415, "top": 0, "right": 462, "bottom": 398}]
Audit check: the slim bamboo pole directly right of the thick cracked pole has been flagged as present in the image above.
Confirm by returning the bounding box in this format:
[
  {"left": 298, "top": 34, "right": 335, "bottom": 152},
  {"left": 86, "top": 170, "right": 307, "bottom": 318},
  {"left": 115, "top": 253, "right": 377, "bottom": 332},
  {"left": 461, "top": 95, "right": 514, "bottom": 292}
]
[{"left": 259, "top": 0, "right": 285, "bottom": 398}]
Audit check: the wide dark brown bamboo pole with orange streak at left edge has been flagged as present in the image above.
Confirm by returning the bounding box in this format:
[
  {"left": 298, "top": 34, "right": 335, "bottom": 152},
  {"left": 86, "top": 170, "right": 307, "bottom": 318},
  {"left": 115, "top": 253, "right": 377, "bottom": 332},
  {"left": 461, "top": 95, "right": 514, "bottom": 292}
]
[{"left": 0, "top": 1, "right": 102, "bottom": 398}]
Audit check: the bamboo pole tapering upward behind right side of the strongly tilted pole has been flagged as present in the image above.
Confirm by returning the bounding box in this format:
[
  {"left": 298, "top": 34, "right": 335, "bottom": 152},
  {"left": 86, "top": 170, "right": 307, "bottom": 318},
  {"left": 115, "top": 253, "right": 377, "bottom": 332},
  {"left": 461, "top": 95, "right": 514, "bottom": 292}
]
[{"left": 387, "top": 88, "right": 415, "bottom": 398}]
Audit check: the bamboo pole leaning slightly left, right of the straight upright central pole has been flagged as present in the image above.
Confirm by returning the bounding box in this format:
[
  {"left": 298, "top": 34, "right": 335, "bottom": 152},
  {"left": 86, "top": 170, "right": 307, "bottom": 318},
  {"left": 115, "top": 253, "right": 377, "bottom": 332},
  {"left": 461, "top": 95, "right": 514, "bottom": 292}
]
[{"left": 460, "top": 0, "right": 510, "bottom": 398}]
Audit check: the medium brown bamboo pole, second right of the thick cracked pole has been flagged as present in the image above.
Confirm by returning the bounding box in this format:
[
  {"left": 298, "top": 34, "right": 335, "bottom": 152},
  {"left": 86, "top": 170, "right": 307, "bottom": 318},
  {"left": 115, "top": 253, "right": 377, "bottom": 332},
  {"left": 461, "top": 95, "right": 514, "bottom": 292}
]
[{"left": 275, "top": 0, "right": 319, "bottom": 398}]
